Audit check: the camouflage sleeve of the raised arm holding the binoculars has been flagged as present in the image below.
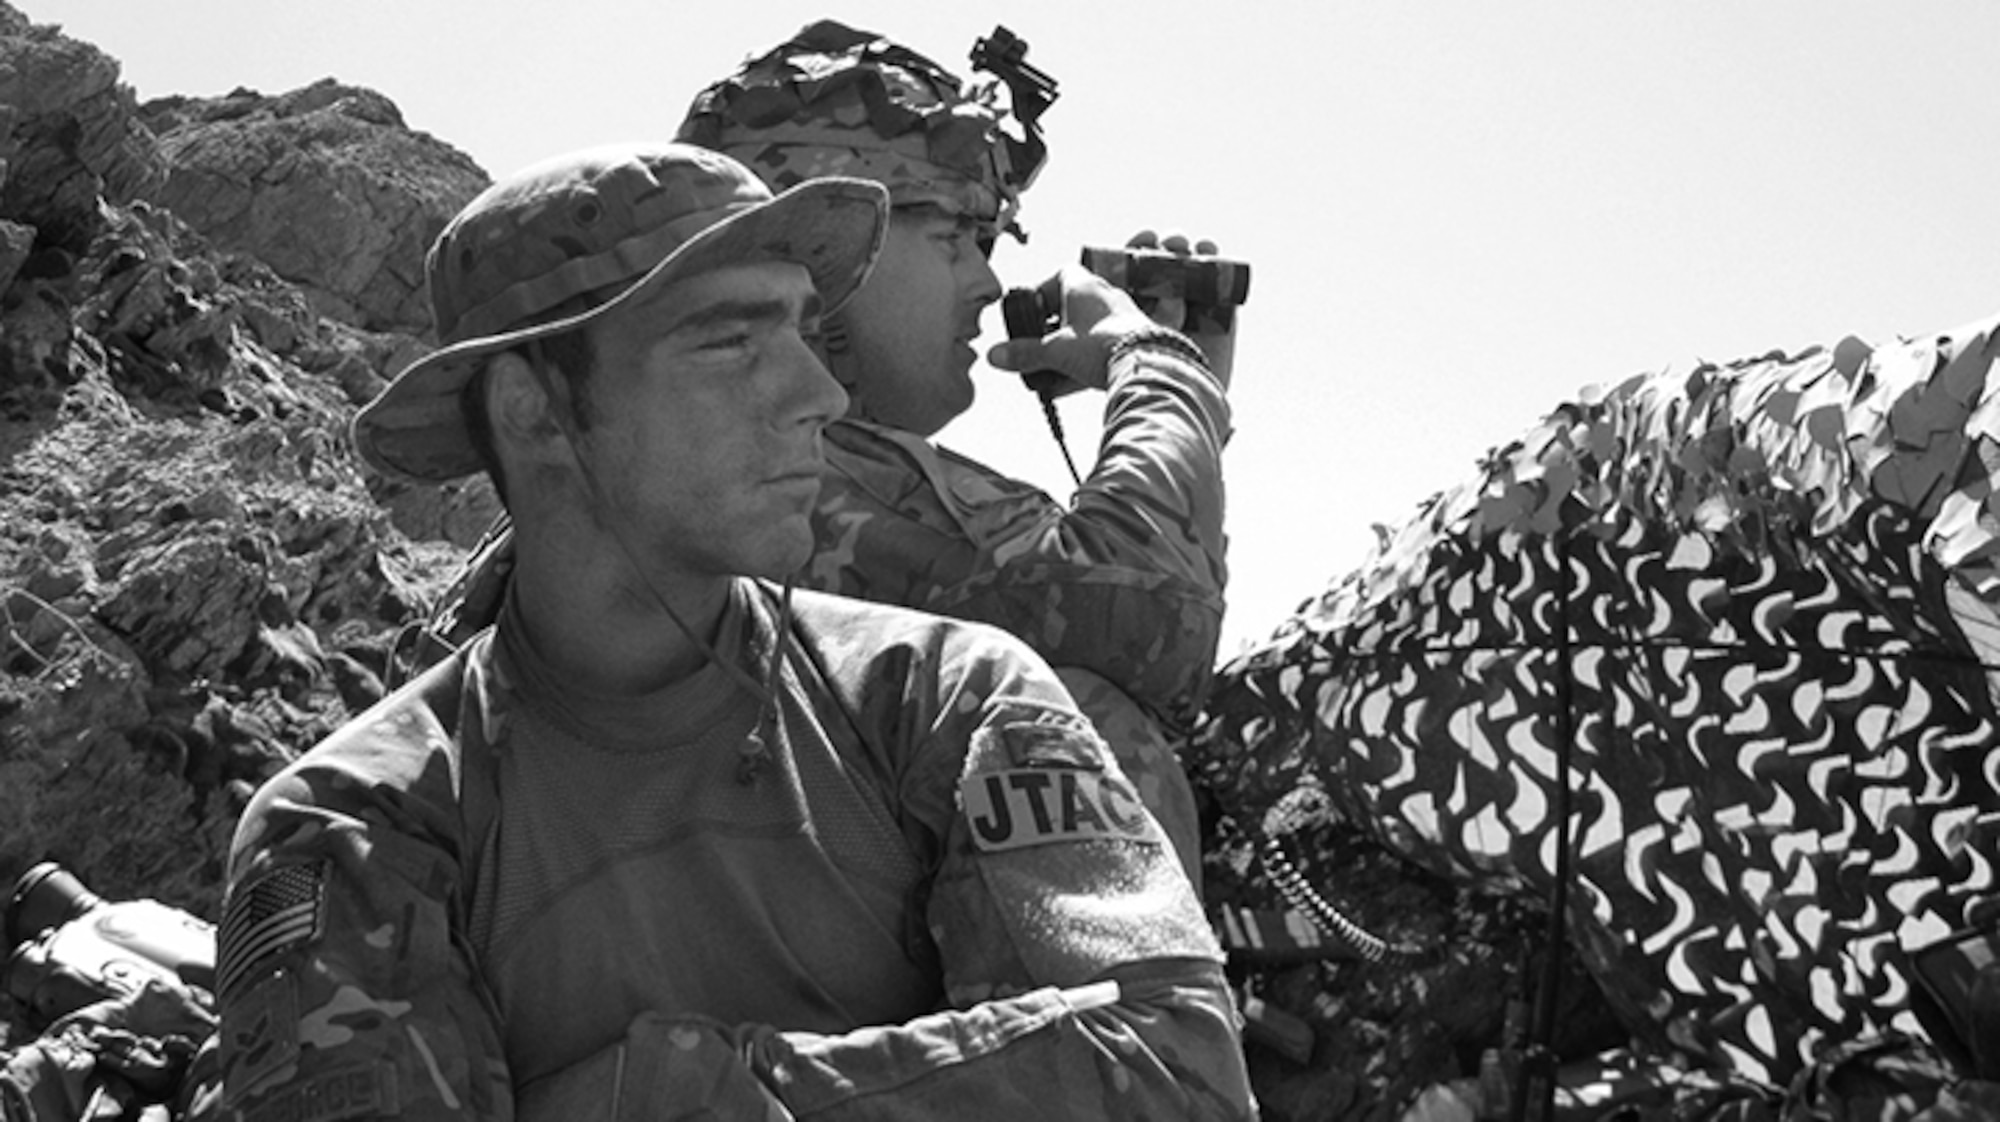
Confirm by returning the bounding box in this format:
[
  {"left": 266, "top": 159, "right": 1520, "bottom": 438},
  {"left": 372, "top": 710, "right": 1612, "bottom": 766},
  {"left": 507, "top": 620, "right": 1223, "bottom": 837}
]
[{"left": 806, "top": 328, "right": 1230, "bottom": 732}]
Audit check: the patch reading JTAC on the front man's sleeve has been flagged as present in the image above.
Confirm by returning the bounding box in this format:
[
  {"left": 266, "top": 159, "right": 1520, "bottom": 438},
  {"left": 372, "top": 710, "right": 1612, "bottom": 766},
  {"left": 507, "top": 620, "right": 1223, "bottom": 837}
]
[{"left": 958, "top": 768, "right": 1166, "bottom": 850}]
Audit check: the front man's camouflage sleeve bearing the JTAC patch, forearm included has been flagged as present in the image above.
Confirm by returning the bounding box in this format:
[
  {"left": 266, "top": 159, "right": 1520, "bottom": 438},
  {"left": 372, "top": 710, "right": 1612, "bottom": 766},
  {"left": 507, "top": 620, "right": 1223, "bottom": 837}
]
[{"left": 740, "top": 612, "right": 1256, "bottom": 1120}]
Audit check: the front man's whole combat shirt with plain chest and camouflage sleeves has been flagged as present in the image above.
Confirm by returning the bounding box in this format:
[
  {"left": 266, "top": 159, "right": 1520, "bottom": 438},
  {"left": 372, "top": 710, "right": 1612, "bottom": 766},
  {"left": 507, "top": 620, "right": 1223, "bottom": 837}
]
[{"left": 218, "top": 584, "right": 1254, "bottom": 1120}]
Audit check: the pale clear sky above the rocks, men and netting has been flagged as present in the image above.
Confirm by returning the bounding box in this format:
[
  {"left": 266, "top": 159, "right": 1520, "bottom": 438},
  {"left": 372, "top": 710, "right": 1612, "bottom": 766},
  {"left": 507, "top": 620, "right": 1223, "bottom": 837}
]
[{"left": 27, "top": 0, "right": 2000, "bottom": 658}]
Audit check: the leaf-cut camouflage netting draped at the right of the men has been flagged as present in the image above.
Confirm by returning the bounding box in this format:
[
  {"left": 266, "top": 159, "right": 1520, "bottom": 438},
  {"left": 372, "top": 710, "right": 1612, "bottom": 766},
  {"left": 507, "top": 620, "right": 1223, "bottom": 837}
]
[{"left": 1196, "top": 310, "right": 2000, "bottom": 1088}]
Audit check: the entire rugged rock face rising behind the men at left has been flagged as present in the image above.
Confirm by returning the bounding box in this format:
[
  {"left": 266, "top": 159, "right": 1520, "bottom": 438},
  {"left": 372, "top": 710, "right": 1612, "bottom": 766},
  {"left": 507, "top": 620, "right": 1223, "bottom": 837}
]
[{"left": 0, "top": 4, "right": 494, "bottom": 936}]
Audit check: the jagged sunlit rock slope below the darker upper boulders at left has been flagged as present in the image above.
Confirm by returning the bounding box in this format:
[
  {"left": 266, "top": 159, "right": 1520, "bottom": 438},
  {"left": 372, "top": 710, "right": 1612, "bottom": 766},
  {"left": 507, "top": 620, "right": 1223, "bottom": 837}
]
[{"left": 0, "top": 190, "right": 460, "bottom": 952}]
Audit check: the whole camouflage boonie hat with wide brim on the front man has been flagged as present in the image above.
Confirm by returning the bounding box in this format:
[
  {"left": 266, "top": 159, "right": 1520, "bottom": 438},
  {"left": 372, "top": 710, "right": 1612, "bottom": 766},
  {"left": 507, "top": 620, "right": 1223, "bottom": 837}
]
[{"left": 354, "top": 144, "right": 888, "bottom": 482}]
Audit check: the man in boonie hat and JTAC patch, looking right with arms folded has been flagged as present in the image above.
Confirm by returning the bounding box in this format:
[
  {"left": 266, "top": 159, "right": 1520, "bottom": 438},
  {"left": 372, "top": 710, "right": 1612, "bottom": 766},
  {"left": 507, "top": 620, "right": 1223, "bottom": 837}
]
[{"left": 216, "top": 144, "right": 1252, "bottom": 1122}]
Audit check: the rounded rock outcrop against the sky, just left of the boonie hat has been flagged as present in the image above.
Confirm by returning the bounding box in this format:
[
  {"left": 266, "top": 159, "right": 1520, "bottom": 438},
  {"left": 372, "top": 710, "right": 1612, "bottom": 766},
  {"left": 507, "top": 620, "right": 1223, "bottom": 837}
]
[{"left": 142, "top": 78, "right": 488, "bottom": 334}]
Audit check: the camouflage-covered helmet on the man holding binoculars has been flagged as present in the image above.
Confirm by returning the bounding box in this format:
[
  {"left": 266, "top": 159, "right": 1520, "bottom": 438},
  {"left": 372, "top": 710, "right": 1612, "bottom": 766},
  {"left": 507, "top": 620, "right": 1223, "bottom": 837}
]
[{"left": 678, "top": 20, "right": 1040, "bottom": 236}]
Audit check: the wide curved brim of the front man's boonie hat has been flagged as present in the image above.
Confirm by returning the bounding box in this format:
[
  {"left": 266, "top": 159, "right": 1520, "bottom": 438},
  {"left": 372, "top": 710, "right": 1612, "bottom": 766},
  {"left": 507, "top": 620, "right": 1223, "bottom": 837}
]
[{"left": 352, "top": 178, "right": 888, "bottom": 482}]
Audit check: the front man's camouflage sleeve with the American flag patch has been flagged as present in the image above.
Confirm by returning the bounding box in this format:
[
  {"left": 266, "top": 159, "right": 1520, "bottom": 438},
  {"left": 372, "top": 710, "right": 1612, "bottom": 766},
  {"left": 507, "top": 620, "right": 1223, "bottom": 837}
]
[{"left": 216, "top": 692, "right": 514, "bottom": 1122}]
